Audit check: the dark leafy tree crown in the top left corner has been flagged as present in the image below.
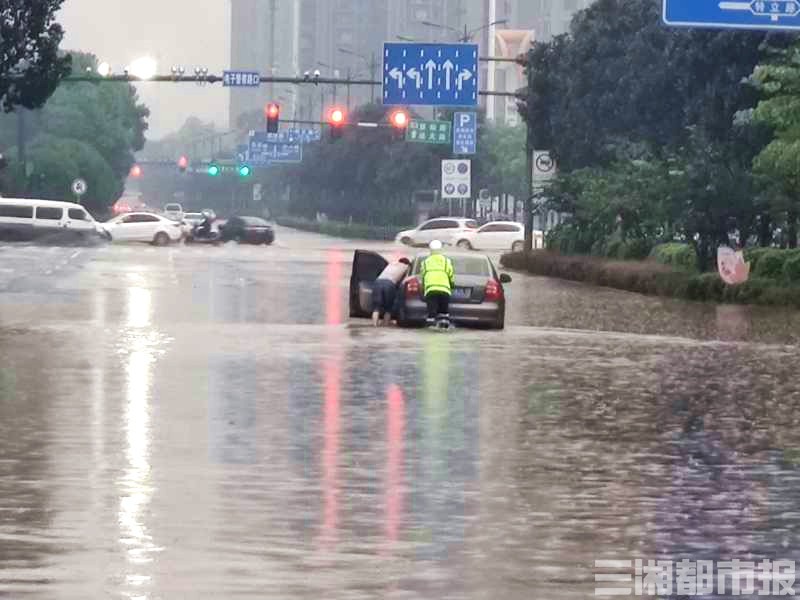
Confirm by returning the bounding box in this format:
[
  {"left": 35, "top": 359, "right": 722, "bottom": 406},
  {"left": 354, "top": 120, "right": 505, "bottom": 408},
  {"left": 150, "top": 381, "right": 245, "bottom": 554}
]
[{"left": 0, "top": 0, "right": 70, "bottom": 112}]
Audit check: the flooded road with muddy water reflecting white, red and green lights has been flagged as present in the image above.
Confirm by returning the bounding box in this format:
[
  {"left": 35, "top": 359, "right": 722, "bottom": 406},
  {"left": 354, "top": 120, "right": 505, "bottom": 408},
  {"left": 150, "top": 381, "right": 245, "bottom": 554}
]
[{"left": 0, "top": 229, "right": 800, "bottom": 600}]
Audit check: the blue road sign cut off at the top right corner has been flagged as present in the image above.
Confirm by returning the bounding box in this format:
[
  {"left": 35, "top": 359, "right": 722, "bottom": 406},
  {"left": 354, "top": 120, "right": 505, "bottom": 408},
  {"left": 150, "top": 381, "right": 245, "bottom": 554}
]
[{"left": 663, "top": 0, "right": 800, "bottom": 30}]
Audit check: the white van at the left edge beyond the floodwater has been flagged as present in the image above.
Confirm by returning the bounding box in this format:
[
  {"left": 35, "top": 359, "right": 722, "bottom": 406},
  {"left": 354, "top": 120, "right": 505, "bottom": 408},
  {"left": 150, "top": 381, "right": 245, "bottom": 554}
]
[{"left": 0, "top": 198, "right": 102, "bottom": 241}]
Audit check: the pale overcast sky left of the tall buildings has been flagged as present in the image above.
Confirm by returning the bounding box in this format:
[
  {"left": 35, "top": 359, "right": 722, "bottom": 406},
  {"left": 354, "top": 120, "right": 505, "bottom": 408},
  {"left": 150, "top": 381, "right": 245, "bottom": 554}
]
[{"left": 58, "top": 0, "right": 230, "bottom": 138}]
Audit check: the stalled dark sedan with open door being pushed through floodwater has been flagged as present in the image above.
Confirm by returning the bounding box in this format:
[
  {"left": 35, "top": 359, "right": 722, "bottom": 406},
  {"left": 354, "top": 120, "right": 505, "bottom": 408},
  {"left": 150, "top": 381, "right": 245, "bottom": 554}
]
[{"left": 350, "top": 250, "right": 511, "bottom": 329}]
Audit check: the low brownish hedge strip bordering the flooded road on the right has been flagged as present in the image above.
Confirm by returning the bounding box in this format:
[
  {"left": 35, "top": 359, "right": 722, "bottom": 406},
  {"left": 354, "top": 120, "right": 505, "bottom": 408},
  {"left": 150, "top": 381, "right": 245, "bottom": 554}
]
[{"left": 500, "top": 250, "right": 800, "bottom": 308}]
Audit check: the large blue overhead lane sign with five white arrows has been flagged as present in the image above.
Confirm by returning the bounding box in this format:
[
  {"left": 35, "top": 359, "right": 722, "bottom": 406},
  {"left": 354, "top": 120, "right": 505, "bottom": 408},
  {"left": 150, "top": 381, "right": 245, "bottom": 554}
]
[{"left": 383, "top": 42, "right": 479, "bottom": 106}]
